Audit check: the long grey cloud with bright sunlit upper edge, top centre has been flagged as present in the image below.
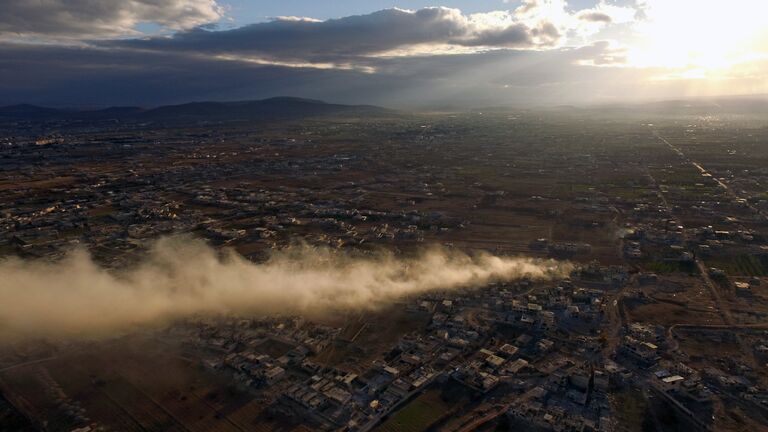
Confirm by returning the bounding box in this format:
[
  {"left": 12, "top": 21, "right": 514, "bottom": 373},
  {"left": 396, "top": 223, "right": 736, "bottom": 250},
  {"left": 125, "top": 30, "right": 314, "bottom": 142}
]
[{"left": 109, "top": 7, "right": 561, "bottom": 62}]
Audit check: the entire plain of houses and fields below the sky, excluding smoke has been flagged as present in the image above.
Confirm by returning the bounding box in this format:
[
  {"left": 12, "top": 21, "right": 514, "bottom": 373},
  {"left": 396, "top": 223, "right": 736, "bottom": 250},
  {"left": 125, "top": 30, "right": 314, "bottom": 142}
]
[{"left": 0, "top": 109, "right": 768, "bottom": 432}]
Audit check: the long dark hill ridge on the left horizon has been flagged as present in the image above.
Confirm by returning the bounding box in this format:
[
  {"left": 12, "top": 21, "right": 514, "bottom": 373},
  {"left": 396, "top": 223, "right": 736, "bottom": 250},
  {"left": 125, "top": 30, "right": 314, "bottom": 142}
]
[{"left": 0, "top": 97, "right": 394, "bottom": 123}]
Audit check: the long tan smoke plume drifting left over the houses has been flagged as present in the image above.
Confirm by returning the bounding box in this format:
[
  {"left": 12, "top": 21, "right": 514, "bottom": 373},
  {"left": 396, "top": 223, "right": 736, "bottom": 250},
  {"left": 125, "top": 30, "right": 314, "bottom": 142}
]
[{"left": 0, "top": 237, "right": 570, "bottom": 338}]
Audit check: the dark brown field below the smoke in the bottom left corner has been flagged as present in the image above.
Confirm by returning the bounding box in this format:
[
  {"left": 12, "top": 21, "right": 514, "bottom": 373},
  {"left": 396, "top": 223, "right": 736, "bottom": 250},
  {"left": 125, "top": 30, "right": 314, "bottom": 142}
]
[{"left": 0, "top": 339, "right": 270, "bottom": 432}]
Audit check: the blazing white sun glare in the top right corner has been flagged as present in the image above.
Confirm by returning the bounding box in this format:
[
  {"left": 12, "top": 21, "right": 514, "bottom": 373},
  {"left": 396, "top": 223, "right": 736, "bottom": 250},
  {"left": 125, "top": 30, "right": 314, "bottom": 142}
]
[{"left": 627, "top": 0, "right": 768, "bottom": 74}]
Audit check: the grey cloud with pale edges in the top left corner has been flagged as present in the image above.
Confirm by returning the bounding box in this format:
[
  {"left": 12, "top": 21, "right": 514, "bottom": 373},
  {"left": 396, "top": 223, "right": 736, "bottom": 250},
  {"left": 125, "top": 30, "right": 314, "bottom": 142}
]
[{"left": 0, "top": 0, "right": 223, "bottom": 38}]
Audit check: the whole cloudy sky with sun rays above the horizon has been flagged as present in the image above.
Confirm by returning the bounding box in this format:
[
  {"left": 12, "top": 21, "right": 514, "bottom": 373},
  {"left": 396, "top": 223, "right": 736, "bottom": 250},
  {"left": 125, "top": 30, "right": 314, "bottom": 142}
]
[{"left": 0, "top": 0, "right": 768, "bottom": 108}]
